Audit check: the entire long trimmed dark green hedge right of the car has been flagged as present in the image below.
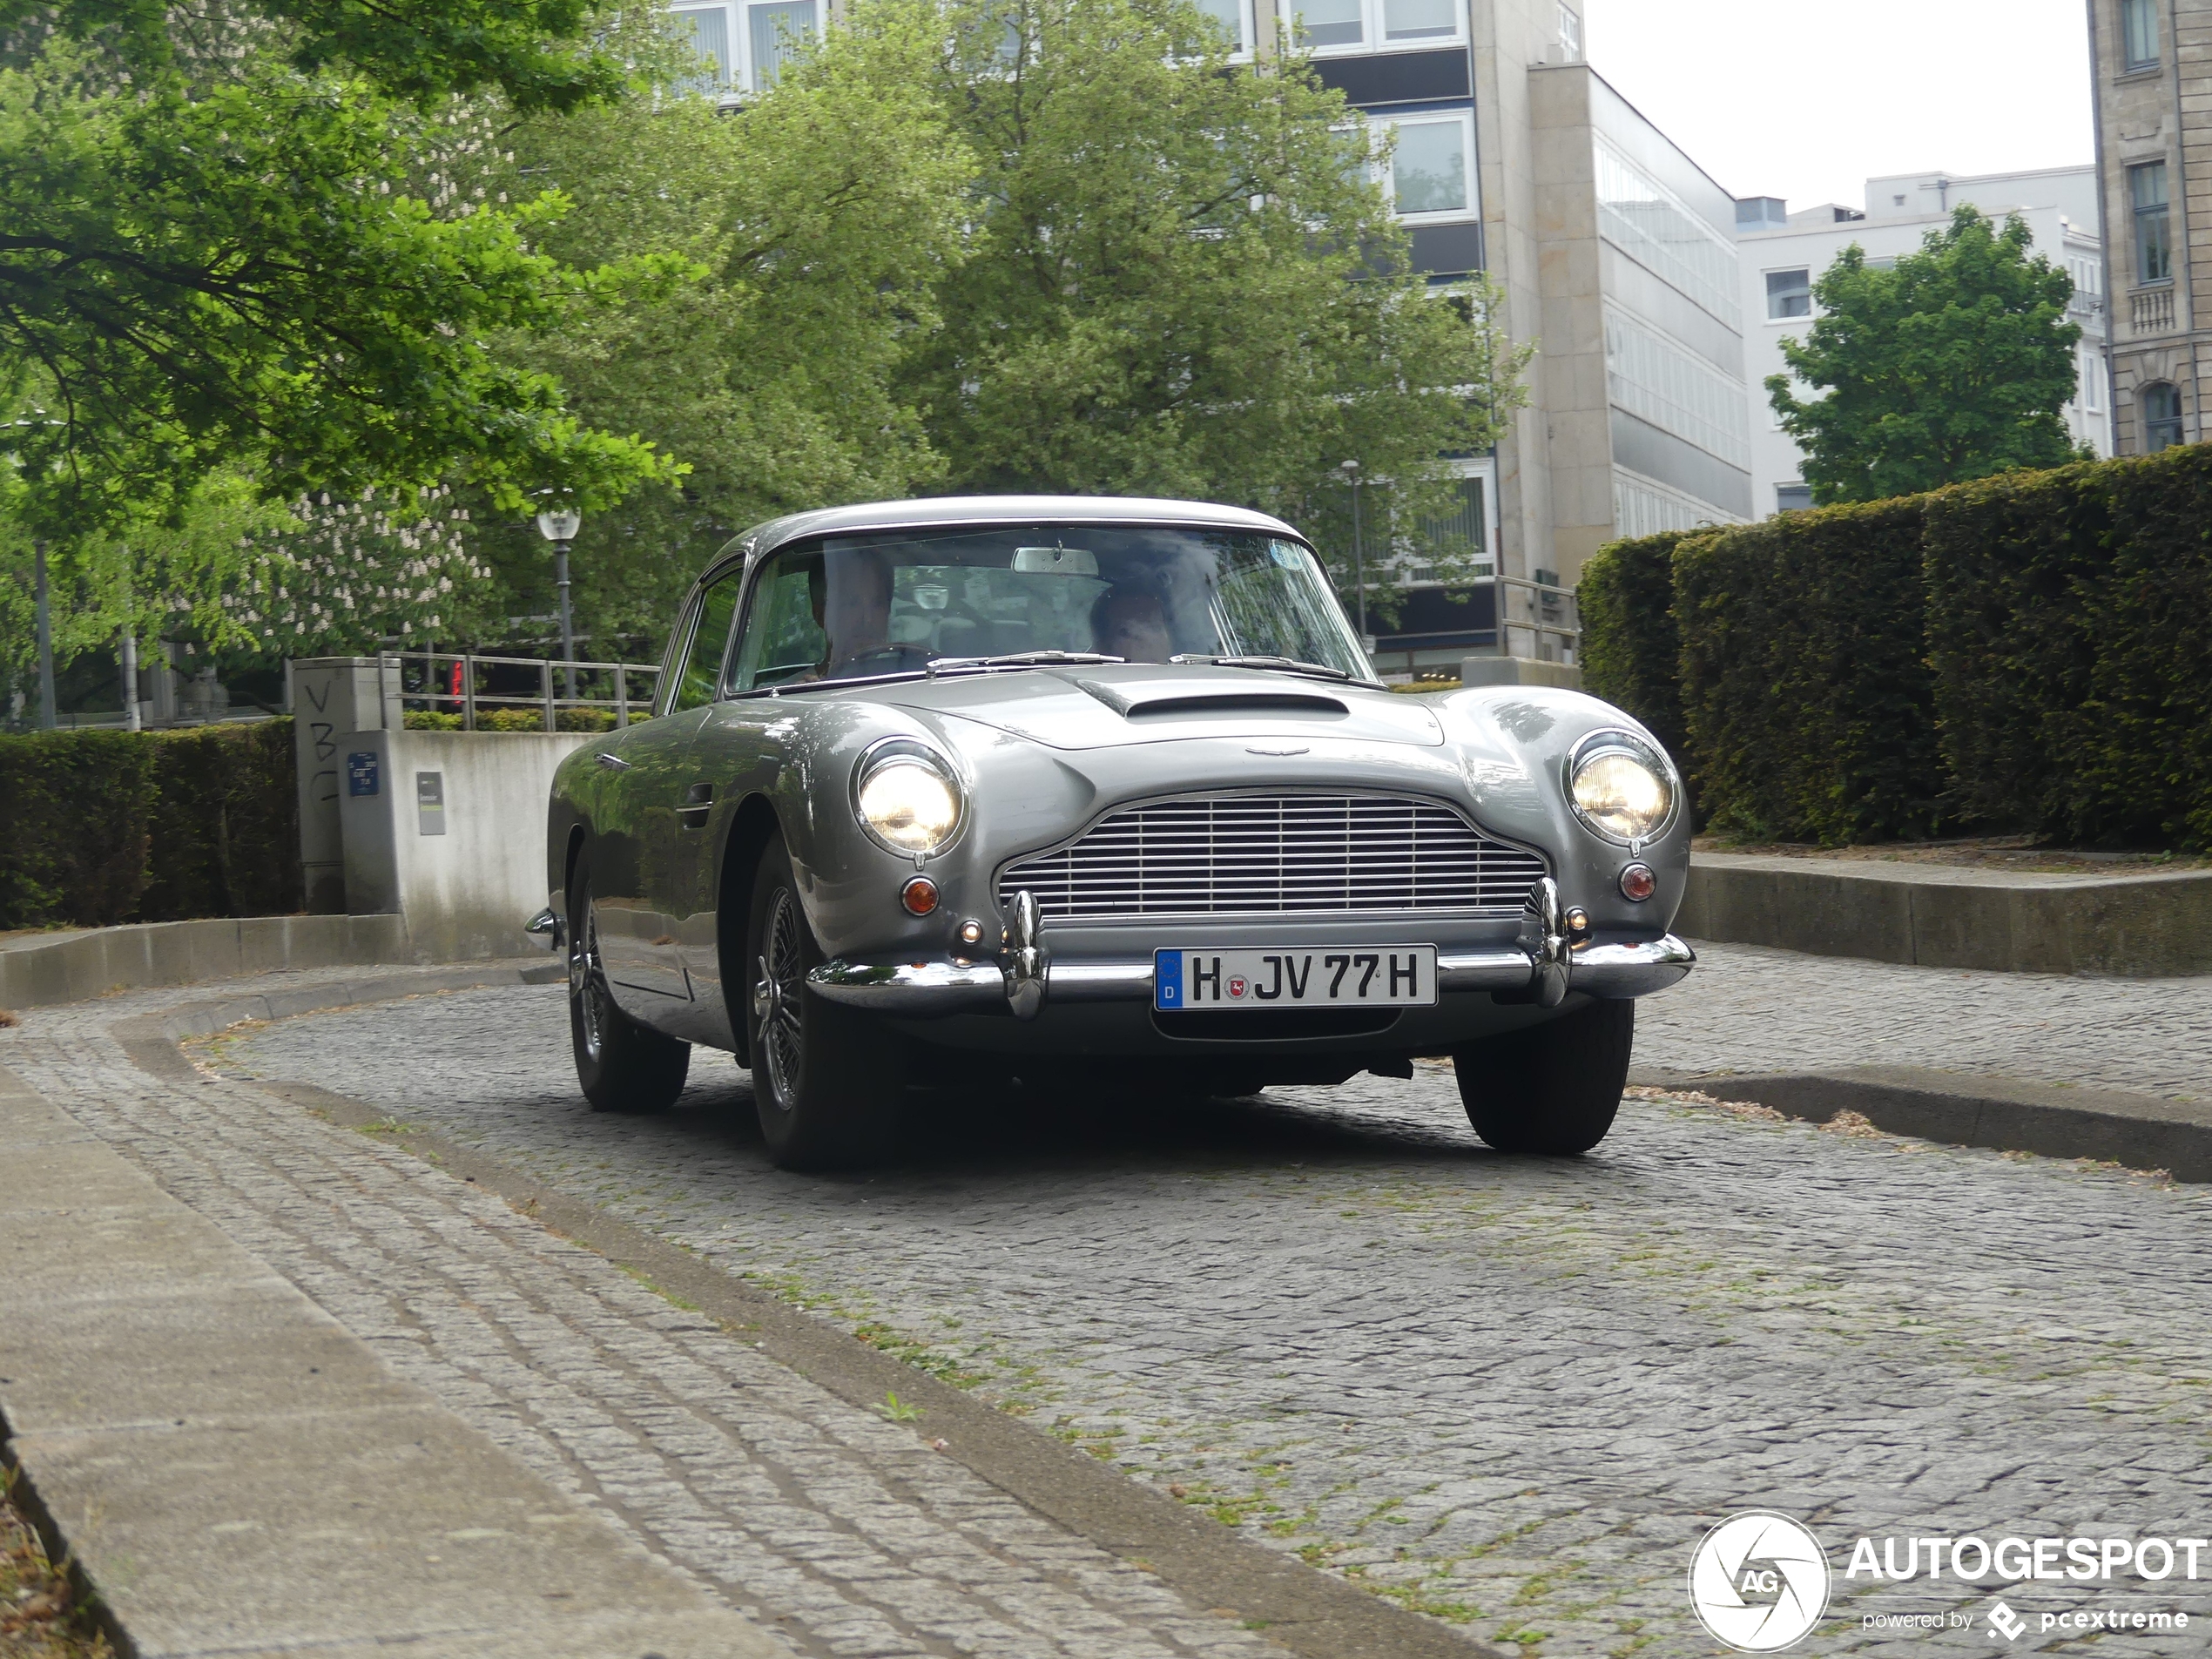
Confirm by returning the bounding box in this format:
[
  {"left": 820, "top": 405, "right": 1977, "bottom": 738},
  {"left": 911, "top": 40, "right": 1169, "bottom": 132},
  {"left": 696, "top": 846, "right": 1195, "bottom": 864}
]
[{"left": 1581, "top": 447, "right": 2212, "bottom": 849}]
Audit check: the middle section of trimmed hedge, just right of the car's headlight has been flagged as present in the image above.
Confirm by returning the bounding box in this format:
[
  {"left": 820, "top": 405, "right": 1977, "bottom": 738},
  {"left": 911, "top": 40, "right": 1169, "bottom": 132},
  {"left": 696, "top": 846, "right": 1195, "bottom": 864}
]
[{"left": 1675, "top": 498, "right": 1946, "bottom": 845}]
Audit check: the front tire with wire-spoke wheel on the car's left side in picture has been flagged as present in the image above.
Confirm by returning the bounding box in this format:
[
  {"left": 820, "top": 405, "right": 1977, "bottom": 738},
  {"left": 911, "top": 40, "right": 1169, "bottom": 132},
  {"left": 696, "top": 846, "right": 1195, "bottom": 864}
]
[{"left": 745, "top": 839, "right": 907, "bottom": 1170}]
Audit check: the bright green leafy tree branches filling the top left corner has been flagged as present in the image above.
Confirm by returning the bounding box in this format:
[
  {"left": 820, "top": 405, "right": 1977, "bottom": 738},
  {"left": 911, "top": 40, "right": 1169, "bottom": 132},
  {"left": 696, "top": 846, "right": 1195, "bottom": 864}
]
[{"left": 0, "top": 0, "right": 671, "bottom": 537}]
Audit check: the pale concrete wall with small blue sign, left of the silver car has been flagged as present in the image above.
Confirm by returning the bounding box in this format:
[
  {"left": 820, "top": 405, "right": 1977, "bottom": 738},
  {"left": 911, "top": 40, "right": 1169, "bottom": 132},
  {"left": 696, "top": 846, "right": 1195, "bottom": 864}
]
[{"left": 339, "top": 730, "right": 595, "bottom": 962}]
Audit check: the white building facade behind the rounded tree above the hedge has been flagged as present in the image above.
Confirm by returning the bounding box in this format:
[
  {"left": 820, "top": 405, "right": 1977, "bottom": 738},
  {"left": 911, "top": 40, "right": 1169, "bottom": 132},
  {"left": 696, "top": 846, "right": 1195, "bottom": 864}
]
[{"left": 1737, "top": 166, "right": 2113, "bottom": 517}]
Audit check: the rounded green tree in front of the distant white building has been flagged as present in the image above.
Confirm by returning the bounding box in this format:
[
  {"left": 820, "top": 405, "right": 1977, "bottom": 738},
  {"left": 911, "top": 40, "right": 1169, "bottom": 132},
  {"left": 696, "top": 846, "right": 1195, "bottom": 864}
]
[{"left": 1767, "top": 206, "right": 2081, "bottom": 504}]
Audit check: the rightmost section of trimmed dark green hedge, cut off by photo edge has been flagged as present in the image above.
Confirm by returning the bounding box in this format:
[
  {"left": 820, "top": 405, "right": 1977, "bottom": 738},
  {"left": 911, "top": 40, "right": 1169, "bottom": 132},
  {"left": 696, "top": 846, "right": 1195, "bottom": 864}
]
[{"left": 1926, "top": 445, "right": 2212, "bottom": 847}]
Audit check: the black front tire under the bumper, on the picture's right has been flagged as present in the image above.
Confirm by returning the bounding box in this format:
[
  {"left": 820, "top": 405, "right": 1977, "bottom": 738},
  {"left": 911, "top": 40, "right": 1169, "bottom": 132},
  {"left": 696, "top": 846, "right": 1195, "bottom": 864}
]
[{"left": 1451, "top": 1002, "right": 1637, "bottom": 1157}]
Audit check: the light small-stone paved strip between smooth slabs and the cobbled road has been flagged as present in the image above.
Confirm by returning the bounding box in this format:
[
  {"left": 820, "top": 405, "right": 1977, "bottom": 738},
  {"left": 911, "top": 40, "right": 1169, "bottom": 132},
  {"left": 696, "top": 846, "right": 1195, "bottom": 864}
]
[{"left": 0, "top": 969, "right": 1281, "bottom": 1659}]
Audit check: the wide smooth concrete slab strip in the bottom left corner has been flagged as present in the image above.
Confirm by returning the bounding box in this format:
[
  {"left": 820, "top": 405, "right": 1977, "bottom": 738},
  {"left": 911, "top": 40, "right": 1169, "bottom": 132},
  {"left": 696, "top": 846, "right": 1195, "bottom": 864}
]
[{"left": 0, "top": 1039, "right": 783, "bottom": 1659}]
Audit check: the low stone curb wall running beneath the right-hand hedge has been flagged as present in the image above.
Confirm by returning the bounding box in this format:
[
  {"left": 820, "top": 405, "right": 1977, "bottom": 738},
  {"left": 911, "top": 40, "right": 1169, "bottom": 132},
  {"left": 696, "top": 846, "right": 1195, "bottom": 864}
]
[{"left": 1675, "top": 852, "right": 2212, "bottom": 980}]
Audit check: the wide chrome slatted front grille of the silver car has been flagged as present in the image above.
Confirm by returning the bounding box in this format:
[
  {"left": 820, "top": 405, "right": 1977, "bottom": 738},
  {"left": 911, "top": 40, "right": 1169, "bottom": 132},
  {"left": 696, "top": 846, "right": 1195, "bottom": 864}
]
[{"left": 998, "top": 794, "right": 1544, "bottom": 921}]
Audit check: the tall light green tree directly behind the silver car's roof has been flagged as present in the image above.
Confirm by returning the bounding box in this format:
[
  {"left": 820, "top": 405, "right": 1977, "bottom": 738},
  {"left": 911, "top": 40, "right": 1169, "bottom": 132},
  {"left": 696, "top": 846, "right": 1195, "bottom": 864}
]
[{"left": 823, "top": 0, "right": 1524, "bottom": 592}]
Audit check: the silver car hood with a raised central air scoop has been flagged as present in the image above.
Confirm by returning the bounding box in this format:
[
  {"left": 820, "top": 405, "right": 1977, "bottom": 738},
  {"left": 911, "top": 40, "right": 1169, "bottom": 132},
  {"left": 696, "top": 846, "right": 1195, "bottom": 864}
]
[{"left": 876, "top": 664, "right": 1445, "bottom": 750}]
